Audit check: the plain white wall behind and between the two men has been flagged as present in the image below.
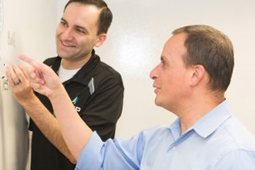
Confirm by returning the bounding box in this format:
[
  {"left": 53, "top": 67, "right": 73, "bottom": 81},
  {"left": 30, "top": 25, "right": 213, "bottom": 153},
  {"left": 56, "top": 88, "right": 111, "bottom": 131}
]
[{"left": 59, "top": 0, "right": 255, "bottom": 137}]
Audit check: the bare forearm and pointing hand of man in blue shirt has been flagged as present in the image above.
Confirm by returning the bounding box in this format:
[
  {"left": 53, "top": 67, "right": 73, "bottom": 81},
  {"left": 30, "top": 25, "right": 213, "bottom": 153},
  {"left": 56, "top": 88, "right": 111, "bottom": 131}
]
[{"left": 19, "top": 55, "right": 92, "bottom": 160}]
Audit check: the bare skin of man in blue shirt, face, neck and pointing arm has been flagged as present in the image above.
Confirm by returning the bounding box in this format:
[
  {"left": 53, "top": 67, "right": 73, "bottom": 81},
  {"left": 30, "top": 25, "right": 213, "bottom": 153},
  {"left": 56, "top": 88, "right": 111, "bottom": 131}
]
[{"left": 5, "top": 33, "right": 224, "bottom": 159}]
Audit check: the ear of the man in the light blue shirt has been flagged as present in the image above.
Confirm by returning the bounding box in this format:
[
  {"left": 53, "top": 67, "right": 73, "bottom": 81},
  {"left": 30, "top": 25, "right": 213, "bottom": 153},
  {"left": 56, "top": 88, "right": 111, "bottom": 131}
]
[{"left": 190, "top": 64, "right": 206, "bottom": 86}]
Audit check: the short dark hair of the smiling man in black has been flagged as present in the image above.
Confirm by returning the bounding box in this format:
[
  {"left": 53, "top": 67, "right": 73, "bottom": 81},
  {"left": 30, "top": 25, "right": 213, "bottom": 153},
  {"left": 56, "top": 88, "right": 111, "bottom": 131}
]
[{"left": 64, "top": 0, "right": 113, "bottom": 35}]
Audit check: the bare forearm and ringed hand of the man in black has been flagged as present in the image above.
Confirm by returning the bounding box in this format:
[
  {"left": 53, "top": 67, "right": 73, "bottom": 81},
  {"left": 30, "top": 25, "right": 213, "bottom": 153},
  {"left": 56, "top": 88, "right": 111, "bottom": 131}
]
[{"left": 6, "top": 64, "right": 76, "bottom": 164}]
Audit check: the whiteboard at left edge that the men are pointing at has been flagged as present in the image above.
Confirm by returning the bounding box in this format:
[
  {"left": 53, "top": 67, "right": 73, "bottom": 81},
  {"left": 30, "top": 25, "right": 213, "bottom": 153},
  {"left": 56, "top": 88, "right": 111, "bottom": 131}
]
[{"left": 0, "top": 0, "right": 57, "bottom": 170}]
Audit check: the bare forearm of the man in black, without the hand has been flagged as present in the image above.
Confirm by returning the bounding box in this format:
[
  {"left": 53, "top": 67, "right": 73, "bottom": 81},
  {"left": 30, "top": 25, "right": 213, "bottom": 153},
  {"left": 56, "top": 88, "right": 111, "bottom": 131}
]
[{"left": 21, "top": 96, "right": 76, "bottom": 164}]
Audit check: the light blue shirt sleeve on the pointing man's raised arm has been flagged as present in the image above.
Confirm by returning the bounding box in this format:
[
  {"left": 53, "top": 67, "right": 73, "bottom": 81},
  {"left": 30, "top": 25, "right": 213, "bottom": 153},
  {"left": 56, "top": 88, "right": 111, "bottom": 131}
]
[{"left": 76, "top": 132, "right": 143, "bottom": 170}]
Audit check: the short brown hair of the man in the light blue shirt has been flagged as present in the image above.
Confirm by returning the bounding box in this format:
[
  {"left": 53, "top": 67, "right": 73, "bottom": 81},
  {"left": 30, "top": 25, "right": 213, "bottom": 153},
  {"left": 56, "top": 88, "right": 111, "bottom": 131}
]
[{"left": 173, "top": 25, "right": 234, "bottom": 91}]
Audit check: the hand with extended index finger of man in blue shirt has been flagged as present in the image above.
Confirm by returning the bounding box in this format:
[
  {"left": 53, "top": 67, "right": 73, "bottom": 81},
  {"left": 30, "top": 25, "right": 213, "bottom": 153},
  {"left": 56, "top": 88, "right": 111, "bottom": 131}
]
[{"left": 19, "top": 55, "right": 62, "bottom": 98}]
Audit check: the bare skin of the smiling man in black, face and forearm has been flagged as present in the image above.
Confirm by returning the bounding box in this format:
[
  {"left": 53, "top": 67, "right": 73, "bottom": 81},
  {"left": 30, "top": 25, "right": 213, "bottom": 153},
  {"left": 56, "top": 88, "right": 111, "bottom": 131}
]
[{"left": 6, "top": 2, "right": 106, "bottom": 164}]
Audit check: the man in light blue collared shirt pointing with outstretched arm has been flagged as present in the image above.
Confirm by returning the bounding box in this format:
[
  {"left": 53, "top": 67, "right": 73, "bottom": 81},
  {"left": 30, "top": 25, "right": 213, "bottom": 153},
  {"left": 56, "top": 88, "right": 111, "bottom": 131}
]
[{"left": 9, "top": 25, "right": 255, "bottom": 170}]
